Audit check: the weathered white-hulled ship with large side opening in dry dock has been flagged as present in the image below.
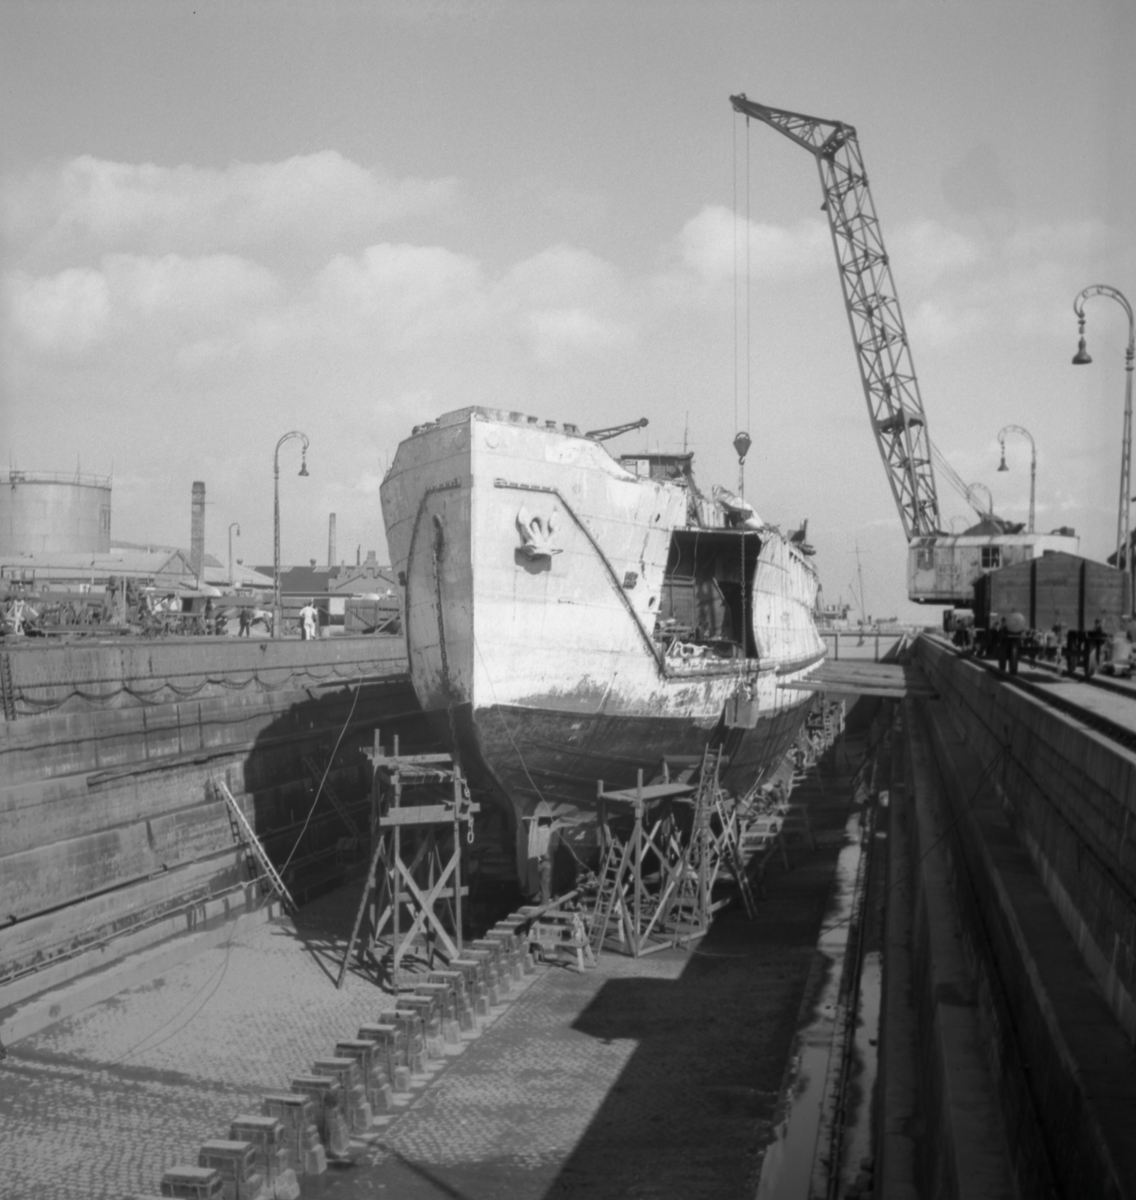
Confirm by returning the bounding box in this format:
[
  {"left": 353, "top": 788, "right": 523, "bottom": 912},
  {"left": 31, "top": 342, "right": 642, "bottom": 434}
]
[{"left": 380, "top": 407, "right": 824, "bottom": 857}]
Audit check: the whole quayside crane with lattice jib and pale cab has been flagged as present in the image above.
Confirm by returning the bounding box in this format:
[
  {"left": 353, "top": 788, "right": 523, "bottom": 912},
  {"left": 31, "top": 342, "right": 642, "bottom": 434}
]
[{"left": 729, "top": 92, "right": 1077, "bottom": 607}]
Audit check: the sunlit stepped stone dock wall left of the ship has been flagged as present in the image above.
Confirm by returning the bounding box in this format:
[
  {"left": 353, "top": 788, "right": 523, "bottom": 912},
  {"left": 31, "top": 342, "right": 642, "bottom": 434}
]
[{"left": 0, "top": 637, "right": 427, "bottom": 988}]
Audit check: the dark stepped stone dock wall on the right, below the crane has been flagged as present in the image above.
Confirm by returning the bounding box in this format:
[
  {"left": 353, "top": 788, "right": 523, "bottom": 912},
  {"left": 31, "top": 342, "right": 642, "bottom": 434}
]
[{"left": 879, "top": 637, "right": 1136, "bottom": 1200}]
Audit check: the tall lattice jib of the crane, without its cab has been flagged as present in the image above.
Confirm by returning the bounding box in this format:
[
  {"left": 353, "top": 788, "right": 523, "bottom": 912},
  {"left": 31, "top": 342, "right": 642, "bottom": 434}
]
[{"left": 729, "top": 94, "right": 942, "bottom": 541}]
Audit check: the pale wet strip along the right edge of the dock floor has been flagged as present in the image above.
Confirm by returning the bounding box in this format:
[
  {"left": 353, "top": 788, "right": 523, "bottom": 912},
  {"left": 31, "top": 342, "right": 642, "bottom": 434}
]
[{"left": 757, "top": 811, "right": 862, "bottom": 1200}]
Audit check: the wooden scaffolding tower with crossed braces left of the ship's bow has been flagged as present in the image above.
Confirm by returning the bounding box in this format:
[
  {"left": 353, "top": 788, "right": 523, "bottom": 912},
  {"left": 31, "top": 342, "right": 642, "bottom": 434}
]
[{"left": 336, "top": 732, "right": 480, "bottom": 992}]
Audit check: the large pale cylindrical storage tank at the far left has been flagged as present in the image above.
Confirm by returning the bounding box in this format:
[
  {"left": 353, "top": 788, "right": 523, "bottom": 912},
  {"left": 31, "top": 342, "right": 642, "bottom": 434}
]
[{"left": 0, "top": 470, "right": 110, "bottom": 554}]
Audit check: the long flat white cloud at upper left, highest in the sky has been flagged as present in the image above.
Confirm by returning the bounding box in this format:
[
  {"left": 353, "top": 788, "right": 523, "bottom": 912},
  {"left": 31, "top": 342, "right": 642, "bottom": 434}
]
[{"left": 0, "top": 150, "right": 457, "bottom": 262}]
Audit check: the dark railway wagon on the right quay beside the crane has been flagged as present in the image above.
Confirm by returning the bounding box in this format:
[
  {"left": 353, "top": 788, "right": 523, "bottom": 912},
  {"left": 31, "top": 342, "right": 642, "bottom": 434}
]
[{"left": 974, "top": 551, "right": 1131, "bottom": 676}]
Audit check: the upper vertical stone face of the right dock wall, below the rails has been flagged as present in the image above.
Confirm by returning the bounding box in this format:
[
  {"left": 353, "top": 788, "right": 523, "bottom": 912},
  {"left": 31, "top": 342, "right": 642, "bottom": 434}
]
[{"left": 916, "top": 637, "right": 1136, "bottom": 1042}]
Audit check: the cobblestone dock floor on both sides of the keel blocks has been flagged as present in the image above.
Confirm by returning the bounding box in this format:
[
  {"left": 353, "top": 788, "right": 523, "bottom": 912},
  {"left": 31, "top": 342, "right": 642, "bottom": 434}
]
[{"left": 0, "top": 748, "right": 849, "bottom": 1200}]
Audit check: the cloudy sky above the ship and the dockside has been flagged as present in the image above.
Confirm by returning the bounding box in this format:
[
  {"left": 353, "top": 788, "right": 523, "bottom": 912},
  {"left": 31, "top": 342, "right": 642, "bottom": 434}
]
[{"left": 0, "top": 0, "right": 1136, "bottom": 620}]
